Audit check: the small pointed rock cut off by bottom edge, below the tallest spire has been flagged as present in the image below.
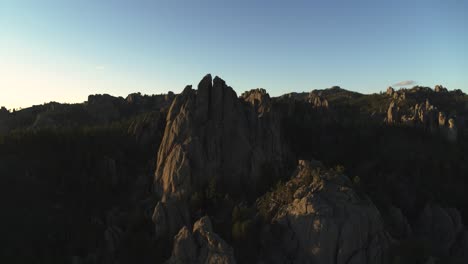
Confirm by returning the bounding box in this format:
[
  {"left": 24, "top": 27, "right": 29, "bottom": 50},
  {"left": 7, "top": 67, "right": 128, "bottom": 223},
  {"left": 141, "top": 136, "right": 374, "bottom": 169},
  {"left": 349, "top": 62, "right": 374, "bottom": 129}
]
[{"left": 166, "top": 216, "right": 236, "bottom": 264}]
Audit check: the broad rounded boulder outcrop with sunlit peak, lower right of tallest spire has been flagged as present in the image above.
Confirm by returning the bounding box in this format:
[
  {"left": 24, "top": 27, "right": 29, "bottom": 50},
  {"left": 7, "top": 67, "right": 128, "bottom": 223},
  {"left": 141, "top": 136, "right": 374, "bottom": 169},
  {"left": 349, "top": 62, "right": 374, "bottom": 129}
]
[{"left": 259, "top": 161, "right": 390, "bottom": 264}]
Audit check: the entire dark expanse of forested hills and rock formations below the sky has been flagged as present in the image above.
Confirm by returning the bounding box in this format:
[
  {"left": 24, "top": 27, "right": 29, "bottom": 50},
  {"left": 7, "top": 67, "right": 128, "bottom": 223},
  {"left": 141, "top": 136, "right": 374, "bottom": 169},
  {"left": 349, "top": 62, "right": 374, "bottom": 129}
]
[{"left": 0, "top": 74, "right": 468, "bottom": 264}]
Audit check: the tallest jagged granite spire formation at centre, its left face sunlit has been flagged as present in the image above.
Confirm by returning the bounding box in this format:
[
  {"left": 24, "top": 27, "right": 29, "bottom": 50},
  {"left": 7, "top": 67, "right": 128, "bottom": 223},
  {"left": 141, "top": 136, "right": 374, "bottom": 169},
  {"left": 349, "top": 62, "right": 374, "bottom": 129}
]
[{"left": 155, "top": 75, "right": 285, "bottom": 199}]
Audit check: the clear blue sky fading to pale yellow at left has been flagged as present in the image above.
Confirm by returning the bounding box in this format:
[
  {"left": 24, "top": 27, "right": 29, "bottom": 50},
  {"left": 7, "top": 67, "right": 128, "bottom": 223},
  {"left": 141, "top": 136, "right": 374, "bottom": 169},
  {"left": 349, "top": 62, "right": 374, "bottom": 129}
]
[{"left": 0, "top": 0, "right": 468, "bottom": 109}]
